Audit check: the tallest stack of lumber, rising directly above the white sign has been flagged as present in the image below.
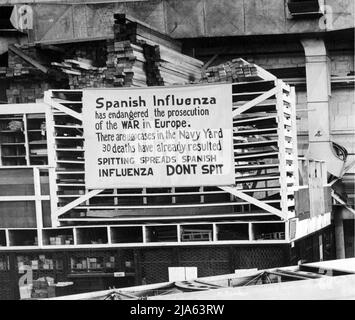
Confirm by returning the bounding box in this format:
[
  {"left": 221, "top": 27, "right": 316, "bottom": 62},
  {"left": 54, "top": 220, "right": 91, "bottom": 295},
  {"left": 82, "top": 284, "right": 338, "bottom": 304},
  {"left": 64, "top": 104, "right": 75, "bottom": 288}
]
[{"left": 107, "top": 14, "right": 203, "bottom": 86}]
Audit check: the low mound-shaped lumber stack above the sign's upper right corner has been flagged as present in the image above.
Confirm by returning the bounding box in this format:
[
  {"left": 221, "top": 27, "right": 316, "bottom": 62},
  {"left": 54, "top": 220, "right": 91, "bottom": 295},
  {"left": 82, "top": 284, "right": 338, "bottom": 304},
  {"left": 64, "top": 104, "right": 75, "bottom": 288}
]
[{"left": 202, "top": 58, "right": 276, "bottom": 82}]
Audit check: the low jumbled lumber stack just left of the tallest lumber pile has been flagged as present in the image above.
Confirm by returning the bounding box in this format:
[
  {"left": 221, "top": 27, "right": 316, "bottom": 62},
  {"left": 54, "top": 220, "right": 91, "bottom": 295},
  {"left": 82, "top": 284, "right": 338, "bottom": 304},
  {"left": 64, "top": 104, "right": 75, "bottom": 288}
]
[{"left": 51, "top": 58, "right": 107, "bottom": 89}]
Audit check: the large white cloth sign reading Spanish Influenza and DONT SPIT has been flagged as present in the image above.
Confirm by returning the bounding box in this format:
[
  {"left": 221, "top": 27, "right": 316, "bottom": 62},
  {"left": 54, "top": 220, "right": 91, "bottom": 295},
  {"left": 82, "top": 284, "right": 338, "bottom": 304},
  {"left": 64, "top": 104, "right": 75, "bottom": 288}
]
[{"left": 83, "top": 84, "right": 234, "bottom": 189}]
